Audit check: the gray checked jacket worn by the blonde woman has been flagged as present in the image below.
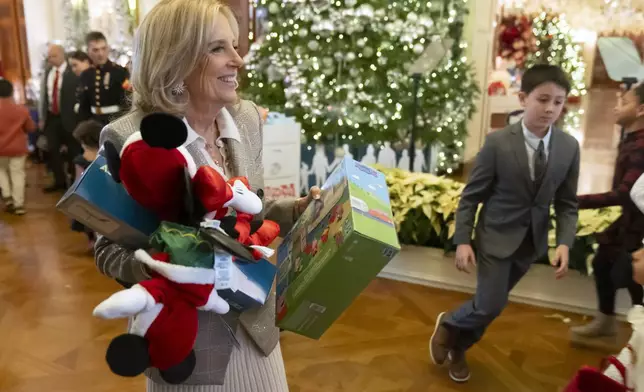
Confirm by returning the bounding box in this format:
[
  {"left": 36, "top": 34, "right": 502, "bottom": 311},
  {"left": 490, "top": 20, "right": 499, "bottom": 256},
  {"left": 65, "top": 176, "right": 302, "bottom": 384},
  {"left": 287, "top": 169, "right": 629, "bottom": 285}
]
[{"left": 95, "top": 101, "right": 297, "bottom": 385}]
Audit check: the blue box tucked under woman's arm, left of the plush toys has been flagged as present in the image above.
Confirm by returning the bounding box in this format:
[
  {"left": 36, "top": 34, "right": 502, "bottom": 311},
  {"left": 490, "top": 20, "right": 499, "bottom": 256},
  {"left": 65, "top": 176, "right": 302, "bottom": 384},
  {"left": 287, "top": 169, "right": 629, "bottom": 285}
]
[{"left": 56, "top": 155, "right": 159, "bottom": 249}]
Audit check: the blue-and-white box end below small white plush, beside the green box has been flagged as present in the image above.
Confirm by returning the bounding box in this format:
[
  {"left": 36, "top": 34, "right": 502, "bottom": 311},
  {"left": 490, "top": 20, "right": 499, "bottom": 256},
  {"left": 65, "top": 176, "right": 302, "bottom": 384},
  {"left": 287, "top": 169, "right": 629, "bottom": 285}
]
[{"left": 215, "top": 252, "right": 277, "bottom": 312}]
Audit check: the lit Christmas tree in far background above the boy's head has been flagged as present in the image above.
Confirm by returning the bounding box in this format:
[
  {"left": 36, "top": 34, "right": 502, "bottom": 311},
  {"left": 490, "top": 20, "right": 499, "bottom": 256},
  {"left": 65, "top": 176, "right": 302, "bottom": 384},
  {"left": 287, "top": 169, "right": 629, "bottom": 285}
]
[{"left": 526, "top": 12, "right": 586, "bottom": 97}]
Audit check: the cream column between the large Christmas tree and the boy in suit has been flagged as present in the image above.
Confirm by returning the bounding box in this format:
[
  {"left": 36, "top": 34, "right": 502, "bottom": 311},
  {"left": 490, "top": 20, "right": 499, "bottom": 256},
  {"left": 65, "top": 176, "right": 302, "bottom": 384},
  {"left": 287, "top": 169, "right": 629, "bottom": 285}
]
[{"left": 463, "top": 0, "right": 498, "bottom": 162}]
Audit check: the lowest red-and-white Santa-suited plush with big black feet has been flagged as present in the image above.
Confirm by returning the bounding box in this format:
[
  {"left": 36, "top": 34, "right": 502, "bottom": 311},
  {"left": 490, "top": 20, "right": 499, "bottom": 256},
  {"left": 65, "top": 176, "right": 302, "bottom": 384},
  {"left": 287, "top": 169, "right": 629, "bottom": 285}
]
[{"left": 94, "top": 250, "right": 230, "bottom": 384}]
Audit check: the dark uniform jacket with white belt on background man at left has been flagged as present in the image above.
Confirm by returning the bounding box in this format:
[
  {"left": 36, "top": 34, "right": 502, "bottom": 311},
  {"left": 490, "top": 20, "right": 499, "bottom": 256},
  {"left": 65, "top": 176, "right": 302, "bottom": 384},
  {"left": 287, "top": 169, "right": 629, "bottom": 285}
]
[{"left": 78, "top": 60, "right": 131, "bottom": 124}]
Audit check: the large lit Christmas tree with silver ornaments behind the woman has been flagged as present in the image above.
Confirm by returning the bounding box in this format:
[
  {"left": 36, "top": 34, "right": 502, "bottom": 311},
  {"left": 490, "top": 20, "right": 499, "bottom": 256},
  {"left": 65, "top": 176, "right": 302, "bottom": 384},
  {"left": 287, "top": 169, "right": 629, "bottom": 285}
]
[{"left": 242, "top": 0, "right": 478, "bottom": 171}]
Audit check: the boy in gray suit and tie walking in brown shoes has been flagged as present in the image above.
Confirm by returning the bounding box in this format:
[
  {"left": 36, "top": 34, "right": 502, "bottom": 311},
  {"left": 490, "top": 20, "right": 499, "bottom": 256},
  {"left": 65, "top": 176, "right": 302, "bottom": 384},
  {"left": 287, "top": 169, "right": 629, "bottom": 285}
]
[{"left": 429, "top": 64, "right": 579, "bottom": 382}]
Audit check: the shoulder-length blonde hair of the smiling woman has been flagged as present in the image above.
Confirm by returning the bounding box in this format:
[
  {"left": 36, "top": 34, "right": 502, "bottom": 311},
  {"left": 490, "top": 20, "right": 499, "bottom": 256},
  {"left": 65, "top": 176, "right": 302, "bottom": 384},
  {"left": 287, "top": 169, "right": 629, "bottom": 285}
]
[{"left": 132, "top": 0, "right": 239, "bottom": 115}]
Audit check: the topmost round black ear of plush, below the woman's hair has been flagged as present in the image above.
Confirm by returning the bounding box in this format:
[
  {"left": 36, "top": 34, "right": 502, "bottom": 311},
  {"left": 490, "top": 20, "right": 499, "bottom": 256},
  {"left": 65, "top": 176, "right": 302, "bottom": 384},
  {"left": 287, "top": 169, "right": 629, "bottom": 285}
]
[{"left": 141, "top": 113, "right": 188, "bottom": 150}]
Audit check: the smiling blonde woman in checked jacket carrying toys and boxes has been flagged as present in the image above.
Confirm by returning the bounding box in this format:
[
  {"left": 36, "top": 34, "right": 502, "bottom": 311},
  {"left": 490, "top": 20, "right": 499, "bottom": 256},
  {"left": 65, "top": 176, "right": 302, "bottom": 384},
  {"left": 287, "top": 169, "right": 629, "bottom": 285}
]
[{"left": 96, "top": 0, "right": 319, "bottom": 392}]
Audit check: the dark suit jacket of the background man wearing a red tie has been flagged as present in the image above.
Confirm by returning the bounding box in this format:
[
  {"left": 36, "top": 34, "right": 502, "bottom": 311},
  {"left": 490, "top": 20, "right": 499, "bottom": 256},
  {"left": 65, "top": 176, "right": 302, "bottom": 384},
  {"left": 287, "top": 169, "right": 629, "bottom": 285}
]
[{"left": 38, "top": 64, "right": 79, "bottom": 133}]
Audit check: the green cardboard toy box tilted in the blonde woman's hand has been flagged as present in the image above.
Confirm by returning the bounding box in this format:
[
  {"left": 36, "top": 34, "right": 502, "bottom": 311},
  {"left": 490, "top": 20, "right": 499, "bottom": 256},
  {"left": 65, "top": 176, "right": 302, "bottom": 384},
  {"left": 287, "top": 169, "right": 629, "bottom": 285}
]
[{"left": 276, "top": 158, "right": 400, "bottom": 339}]
